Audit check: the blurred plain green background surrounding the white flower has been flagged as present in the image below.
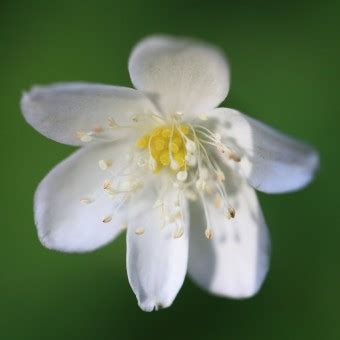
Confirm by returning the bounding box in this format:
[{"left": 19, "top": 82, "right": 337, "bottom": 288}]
[{"left": 0, "top": 0, "right": 340, "bottom": 340}]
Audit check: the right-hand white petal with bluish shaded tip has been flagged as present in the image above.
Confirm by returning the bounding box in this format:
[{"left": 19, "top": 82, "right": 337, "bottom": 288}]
[{"left": 209, "top": 108, "right": 319, "bottom": 193}]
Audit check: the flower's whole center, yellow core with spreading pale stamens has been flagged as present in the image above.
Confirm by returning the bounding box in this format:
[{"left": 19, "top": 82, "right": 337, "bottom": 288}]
[{"left": 77, "top": 112, "right": 241, "bottom": 239}]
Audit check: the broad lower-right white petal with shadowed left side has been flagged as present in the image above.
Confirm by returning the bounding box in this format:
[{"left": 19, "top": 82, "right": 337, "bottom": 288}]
[{"left": 188, "top": 170, "right": 270, "bottom": 298}]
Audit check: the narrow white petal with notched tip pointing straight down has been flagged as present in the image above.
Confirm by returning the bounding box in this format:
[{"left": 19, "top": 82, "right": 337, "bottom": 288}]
[{"left": 127, "top": 188, "right": 188, "bottom": 311}]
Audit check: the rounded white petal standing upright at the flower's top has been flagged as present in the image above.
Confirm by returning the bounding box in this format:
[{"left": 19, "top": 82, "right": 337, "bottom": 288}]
[{"left": 129, "top": 36, "right": 229, "bottom": 114}]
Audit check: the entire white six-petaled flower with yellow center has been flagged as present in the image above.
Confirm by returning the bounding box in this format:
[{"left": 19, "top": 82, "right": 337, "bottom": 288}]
[{"left": 21, "top": 36, "right": 318, "bottom": 311}]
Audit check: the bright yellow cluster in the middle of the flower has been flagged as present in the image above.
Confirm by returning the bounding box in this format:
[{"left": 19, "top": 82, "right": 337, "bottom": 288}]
[{"left": 136, "top": 124, "right": 190, "bottom": 172}]
